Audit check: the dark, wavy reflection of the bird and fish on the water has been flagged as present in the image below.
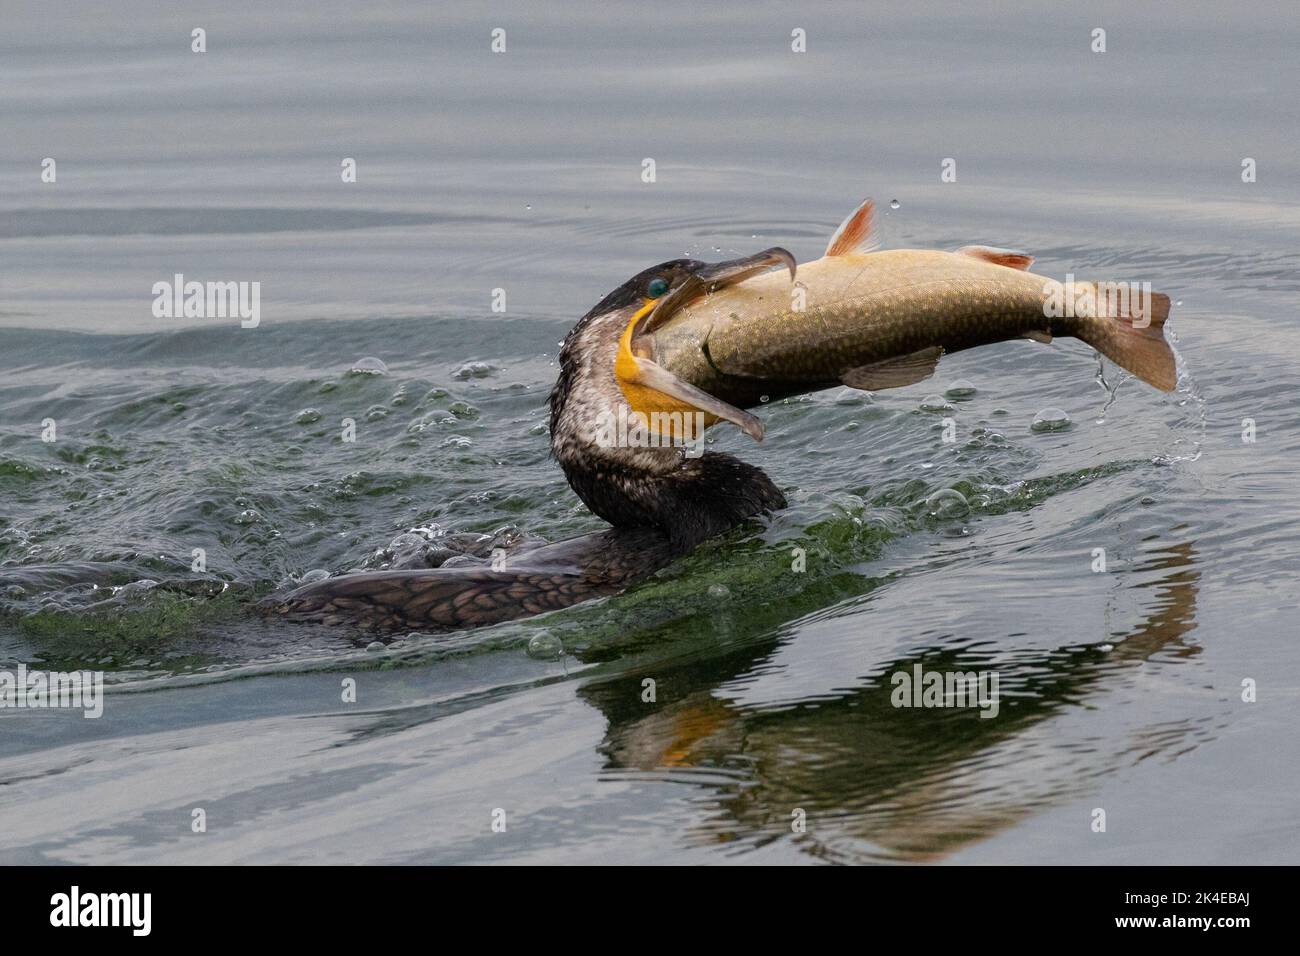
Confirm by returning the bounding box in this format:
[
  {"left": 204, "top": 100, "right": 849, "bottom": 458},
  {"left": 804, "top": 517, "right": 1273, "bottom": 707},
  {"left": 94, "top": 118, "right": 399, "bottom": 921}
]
[{"left": 581, "top": 542, "right": 1208, "bottom": 862}]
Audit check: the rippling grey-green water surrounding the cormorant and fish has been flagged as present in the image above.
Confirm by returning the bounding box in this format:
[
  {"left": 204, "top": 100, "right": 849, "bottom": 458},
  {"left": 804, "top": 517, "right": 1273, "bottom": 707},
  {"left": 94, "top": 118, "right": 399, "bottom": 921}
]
[{"left": 0, "top": 3, "right": 1300, "bottom": 862}]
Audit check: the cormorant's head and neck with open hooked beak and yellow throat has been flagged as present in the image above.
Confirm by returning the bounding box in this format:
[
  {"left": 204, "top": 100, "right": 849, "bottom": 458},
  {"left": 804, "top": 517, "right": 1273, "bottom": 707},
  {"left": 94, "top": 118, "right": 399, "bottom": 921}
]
[{"left": 550, "top": 248, "right": 796, "bottom": 544}]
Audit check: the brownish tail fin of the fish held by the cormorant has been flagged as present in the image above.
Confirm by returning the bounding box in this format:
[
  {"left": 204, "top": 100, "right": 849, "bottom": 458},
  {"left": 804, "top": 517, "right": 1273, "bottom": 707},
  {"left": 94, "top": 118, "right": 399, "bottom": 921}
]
[{"left": 1075, "top": 282, "right": 1178, "bottom": 392}]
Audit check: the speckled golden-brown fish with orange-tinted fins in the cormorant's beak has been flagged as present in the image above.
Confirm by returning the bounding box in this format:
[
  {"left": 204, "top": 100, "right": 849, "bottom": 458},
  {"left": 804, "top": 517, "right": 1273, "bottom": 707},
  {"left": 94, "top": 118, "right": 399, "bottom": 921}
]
[{"left": 620, "top": 199, "right": 1178, "bottom": 438}]
